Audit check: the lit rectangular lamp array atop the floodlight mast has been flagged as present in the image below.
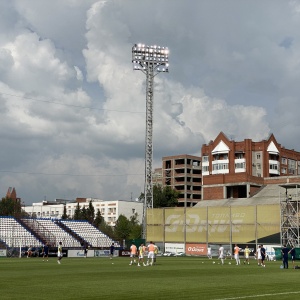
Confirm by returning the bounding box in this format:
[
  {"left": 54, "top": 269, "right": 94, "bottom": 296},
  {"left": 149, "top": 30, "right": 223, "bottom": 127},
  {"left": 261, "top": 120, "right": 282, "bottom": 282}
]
[{"left": 132, "top": 44, "right": 169, "bottom": 72}]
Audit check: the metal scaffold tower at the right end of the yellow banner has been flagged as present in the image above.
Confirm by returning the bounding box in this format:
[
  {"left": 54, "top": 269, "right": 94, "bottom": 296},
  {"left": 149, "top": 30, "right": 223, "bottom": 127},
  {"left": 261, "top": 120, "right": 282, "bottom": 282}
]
[{"left": 280, "top": 184, "right": 300, "bottom": 247}]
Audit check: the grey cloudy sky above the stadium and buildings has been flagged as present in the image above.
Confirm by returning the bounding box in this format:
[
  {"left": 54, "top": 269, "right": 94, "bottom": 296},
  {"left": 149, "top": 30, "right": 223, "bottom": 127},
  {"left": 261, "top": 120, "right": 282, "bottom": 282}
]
[{"left": 0, "top": 0, "right": 300, "bottom": 205}]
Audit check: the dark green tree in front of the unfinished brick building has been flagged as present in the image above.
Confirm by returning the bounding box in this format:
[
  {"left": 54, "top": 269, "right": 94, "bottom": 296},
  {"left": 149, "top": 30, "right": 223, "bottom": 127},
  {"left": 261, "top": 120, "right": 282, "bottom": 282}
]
[{"left": 153, "top": 185, "right": 180, "bottom": 208}]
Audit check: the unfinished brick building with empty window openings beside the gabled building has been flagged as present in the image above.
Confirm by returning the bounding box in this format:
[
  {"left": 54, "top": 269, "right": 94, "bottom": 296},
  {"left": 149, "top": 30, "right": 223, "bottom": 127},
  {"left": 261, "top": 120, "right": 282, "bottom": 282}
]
[{"left": 162, "top": 154, "right": 202, "bottom": 207}]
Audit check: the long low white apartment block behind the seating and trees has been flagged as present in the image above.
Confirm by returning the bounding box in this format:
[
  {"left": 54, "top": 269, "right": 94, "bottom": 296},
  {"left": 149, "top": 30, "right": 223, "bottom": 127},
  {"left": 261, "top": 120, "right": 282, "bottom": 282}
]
[{"left": 25, "top": 198, "right": 143, "bottom": 226}]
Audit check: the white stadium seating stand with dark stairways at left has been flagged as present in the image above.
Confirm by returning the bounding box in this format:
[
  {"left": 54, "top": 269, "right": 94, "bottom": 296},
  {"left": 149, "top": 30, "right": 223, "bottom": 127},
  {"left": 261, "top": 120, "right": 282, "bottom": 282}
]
[{"left": 0, "top": 217, "right": 119, "bottom": 248}]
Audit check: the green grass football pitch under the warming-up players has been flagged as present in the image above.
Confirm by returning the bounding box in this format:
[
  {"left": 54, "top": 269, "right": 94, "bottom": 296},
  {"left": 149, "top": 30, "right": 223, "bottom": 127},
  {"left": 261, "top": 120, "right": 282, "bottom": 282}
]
[{"left": 0, "top": 257, "right": 300, "bottom": 300}]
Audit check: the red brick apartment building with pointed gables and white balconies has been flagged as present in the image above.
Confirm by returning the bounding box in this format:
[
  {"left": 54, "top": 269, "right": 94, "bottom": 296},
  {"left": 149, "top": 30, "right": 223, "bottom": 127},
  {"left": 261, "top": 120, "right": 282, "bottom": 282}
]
[{"left": 201, "top": 132, "right": 300, "bottom": 200}]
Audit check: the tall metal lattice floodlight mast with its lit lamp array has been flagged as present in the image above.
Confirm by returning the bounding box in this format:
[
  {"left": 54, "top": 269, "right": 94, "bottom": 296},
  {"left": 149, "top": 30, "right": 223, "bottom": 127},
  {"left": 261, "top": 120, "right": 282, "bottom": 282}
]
[{"left": 132, "top": 44, "right": 169, "bottom": 238}]
